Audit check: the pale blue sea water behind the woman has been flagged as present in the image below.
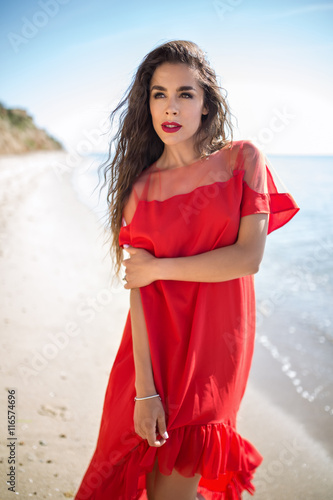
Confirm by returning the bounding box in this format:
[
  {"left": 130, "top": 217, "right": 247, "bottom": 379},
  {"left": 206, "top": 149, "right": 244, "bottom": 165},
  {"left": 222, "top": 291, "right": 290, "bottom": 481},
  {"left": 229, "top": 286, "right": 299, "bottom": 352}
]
[{"left": 73, "top": 155, "right": 333, "bottom": 453}]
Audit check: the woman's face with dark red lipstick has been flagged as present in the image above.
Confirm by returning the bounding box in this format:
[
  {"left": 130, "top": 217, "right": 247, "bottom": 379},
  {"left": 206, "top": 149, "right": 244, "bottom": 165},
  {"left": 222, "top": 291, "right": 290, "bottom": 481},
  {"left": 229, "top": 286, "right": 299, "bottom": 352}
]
[{"left": 149, "top": 63, "right": 208, "bottom": 146}]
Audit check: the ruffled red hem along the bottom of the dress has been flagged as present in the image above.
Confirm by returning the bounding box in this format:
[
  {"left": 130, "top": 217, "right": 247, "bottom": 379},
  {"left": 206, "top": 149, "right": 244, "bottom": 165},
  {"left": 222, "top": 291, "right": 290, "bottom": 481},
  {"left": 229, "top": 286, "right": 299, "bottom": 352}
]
[{"left": 76, "top": 423, "right": 262, "bottom": 500}]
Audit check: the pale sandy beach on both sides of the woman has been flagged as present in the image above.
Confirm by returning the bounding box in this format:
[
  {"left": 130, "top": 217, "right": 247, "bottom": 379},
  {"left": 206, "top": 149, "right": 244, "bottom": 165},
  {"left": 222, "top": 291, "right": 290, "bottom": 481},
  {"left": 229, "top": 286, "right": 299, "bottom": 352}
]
[{"left": 0, "top": 153, "right": 333, "bottom": 500}]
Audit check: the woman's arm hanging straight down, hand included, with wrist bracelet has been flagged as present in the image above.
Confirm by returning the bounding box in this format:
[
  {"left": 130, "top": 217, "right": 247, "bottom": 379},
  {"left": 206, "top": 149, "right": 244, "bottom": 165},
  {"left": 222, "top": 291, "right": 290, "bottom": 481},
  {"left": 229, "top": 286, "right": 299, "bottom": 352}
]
[{"left": 130, "top": 288, "right": 167, "bottom": 446}]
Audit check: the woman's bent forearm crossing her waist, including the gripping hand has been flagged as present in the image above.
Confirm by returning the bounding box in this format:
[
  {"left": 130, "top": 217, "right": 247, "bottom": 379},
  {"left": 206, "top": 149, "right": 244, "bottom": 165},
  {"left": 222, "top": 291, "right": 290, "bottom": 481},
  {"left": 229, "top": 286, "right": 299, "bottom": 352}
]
[{"left": 123, "top": 214, "right": 269, "bottom": 288}]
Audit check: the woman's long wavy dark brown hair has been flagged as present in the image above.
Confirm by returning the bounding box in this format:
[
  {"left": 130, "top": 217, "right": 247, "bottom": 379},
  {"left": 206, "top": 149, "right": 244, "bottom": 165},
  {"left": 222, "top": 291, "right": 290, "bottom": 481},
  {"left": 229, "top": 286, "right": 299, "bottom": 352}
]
[{"left": 101, "top": 40, "right": 232, "bottom": 276}]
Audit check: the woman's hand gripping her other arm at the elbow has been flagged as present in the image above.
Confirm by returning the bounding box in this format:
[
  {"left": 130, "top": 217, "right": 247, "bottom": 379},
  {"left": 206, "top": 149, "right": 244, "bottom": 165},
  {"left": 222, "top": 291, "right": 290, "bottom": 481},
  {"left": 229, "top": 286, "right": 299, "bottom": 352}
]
[{"left": 123, "top": 246, "right": 158, "bottom": 290}]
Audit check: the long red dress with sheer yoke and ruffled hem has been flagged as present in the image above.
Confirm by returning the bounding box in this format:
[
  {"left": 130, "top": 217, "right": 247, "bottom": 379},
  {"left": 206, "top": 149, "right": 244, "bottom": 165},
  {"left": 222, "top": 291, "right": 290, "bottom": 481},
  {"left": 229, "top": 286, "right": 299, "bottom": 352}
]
[{"left": 76, "top": 141, "right": 299, "bottom": 500}]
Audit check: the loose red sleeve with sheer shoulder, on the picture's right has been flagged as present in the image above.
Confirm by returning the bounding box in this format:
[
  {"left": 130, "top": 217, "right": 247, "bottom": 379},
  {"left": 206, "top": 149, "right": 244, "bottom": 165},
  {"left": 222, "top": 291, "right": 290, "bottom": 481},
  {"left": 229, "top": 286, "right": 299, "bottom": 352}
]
[{"left": 235, "top": 141, "right": 299, "bottom": 234}]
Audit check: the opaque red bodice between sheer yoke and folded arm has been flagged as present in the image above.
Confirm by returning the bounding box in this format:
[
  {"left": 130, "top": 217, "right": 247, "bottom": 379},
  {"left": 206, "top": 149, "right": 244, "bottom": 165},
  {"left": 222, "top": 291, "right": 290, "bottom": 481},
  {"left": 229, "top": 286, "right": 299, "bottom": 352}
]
[{"left": 129, "top": 175, "right": 243, "bottom": 257}]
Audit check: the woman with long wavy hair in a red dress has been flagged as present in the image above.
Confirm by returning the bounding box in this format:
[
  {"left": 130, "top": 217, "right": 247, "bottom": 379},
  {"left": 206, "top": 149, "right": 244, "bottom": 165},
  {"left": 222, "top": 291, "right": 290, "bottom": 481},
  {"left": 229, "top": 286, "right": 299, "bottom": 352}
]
[{"left": 76, "top": 41, "right": 298, "bottom": 500}]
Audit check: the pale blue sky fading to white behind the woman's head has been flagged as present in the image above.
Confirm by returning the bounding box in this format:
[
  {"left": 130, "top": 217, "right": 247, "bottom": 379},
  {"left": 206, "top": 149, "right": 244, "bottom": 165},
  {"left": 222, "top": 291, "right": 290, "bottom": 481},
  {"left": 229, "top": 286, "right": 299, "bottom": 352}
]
[{"left": 0, "top": 0, "right": 333, "bottom": 155}]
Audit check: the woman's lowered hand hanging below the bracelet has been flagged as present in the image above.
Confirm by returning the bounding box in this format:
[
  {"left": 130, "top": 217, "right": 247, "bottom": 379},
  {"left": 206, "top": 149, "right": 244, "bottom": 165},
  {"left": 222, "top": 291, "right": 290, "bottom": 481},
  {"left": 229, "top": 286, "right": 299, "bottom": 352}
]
[{"left": 134, "top": 398, "right": 169, "bottom": 447}]
